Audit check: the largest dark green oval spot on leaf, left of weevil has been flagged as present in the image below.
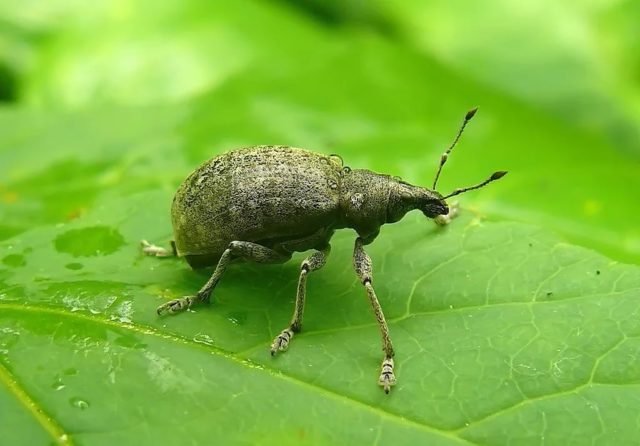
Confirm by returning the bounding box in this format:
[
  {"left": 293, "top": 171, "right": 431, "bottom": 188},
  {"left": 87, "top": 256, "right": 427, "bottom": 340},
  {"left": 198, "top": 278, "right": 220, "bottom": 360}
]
[{"left": 55, "top": 226, "right": 125, "bottom": 257}]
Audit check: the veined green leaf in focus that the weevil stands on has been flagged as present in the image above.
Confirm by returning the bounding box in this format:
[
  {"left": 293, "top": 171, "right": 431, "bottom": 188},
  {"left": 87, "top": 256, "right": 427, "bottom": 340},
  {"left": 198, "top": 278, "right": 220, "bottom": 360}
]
[{"left": 0, "top": 198, "right": 640, "bottom": 444}]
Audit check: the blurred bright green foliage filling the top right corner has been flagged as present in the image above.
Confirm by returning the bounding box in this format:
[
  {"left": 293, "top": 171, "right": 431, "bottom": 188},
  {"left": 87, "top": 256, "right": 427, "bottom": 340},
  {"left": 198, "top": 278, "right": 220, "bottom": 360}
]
[{"left": 280, "top": 0, "right": 640, "bottom": 156}]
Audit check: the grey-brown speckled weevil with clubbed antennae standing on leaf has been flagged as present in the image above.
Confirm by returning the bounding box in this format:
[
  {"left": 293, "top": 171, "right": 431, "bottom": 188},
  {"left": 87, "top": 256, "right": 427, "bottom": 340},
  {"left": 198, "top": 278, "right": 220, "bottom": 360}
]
[{"left": 142, "top": 109, "right": 507, "bottom": 393}]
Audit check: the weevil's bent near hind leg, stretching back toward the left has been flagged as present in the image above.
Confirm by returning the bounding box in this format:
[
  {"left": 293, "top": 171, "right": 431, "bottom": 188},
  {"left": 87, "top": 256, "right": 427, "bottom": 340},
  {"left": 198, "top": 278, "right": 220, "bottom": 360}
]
[{"left": 156, "top": 241, "right": 291, "bottom": 315}]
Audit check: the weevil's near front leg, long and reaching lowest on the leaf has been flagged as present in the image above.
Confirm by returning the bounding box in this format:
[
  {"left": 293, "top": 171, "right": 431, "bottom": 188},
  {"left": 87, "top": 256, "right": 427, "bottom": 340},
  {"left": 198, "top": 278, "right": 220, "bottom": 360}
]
[{"left": 353, "top": 237, "right": 396, "bottom": 393}]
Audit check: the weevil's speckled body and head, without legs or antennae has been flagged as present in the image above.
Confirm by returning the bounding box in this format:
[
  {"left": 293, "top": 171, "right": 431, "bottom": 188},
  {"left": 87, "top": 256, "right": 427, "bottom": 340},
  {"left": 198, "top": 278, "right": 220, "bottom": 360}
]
[{"left": 171, "top": 146, "right": 447, "bottom": 268}]
